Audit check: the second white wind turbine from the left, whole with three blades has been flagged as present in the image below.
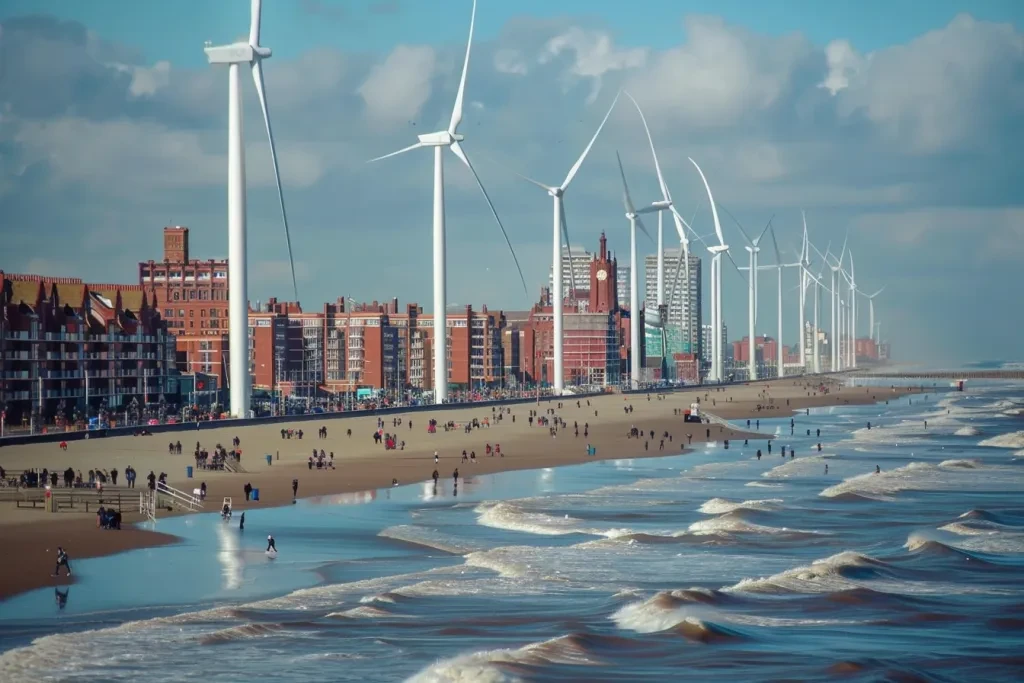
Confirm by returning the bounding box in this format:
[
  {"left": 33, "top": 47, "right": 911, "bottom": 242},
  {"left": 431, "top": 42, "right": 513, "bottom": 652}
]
[{"left": 367, "top": 0, "right": 528, "bottom": 404}]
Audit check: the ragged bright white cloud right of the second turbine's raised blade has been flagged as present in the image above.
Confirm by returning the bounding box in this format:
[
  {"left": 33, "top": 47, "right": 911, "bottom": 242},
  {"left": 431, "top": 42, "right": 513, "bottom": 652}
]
[{"left": 538, "top": 27, "right": 647, "bottom": 103}]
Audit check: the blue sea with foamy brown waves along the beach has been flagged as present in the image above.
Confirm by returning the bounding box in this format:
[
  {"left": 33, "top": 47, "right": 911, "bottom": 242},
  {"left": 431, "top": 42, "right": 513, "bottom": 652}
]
[{"left": 0, "top": 380, "right": 1024, "bottom": 683}]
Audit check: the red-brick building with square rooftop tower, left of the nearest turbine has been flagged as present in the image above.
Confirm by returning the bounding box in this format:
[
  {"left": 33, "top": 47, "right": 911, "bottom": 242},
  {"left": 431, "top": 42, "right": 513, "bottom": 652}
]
[{"left": 138, "top": 225, "right": 228, "bottom": 386}]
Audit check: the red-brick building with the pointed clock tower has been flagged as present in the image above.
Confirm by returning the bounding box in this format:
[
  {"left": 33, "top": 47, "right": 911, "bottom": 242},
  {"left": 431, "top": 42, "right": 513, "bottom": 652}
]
[{"left": 519, "top": 233, "right": 643, "bottom": 385}]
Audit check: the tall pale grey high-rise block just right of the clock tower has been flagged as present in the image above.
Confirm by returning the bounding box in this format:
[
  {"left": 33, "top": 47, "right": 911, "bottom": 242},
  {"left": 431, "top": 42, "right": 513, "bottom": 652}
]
[{"left": 644, "top": 247, "right": 701, "bottom": 358}]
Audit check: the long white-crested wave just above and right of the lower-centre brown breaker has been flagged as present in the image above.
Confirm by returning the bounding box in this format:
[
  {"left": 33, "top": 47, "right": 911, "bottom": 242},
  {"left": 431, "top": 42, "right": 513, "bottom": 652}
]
[{"left": 722, "top": 551, "right": 891, "bottom": 594}]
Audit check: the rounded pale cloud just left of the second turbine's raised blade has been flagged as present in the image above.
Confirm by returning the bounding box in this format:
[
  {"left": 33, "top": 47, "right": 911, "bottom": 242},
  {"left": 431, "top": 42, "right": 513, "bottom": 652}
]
[{"left": 357, "top": 45, "right": 436, "bottom": 125}]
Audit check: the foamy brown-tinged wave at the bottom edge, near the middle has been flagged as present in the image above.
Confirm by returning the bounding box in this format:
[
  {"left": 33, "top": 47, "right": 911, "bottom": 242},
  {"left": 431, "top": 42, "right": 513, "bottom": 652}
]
[{"left": 407, "top": 634, "right": 611, "bottom": 683}]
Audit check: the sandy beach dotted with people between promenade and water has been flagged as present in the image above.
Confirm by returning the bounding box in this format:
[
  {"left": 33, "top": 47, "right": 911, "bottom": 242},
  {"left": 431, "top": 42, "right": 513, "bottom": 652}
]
[{"left": 0, "top": 378, "right": 909, "bottom": 600}]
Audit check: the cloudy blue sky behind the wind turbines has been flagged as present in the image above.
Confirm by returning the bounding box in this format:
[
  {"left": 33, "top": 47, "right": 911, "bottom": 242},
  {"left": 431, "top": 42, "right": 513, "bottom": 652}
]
[{"left": 0, "top": 0, "right": 1024, "bottom": 364}]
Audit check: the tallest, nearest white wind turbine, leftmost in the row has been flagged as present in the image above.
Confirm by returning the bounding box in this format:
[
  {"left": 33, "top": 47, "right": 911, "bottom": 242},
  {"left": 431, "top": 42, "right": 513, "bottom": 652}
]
[{"left": 204, "top": 0, "right": 299, "bottom": 418}]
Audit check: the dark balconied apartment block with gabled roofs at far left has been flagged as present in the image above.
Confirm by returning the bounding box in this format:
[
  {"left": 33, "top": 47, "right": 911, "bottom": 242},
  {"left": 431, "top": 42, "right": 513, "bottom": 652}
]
[{"left": 0, "top": 271, "right": 174, "bottom": 424}]
